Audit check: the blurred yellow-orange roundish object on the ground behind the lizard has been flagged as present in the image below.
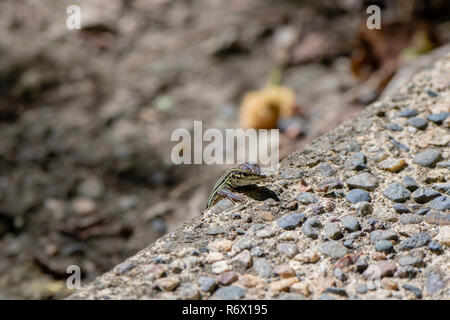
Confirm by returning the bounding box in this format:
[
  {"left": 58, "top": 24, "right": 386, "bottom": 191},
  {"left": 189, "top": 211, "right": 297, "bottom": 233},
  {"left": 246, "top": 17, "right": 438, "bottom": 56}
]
[{"left": 240, "top": 86, "right": 295, "bottom": 129}]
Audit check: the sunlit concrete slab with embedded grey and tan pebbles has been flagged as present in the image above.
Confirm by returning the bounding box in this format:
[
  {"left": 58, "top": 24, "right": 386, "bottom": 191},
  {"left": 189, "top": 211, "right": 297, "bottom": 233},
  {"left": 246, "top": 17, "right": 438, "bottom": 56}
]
[{"left": 71, "top": 55, "right": 450, "bottom": 299}]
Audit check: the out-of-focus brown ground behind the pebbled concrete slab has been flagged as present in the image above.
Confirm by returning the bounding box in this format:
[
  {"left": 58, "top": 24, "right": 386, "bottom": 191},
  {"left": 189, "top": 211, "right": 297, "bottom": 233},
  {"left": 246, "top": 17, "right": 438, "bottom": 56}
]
[{"left": 0, "top": 0, "right": 450, "bottom": 299}]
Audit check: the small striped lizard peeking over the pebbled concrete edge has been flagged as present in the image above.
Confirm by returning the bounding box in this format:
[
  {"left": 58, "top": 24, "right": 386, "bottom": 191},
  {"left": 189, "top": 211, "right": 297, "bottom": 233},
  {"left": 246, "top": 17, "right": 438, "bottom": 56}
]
[{"left": 206, "top": 162, "right": 267, "bottom": 209}]
